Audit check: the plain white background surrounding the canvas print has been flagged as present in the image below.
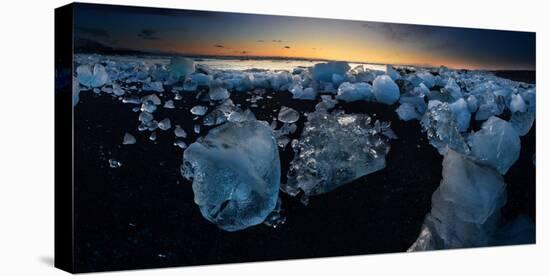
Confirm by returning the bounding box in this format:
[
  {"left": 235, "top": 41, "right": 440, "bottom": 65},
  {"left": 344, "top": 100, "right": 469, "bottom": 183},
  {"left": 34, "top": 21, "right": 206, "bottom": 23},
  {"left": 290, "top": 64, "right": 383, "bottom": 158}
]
[{"left": 0, "top": 0, "right": 550, "bottom": 276}]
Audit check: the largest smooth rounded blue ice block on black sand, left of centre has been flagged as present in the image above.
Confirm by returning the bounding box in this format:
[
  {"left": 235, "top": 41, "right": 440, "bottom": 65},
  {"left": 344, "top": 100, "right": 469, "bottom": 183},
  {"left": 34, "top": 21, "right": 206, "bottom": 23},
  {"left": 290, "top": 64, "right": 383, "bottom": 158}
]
[{"left": 182, "top": 120, "right": 281, "bottom": 231}]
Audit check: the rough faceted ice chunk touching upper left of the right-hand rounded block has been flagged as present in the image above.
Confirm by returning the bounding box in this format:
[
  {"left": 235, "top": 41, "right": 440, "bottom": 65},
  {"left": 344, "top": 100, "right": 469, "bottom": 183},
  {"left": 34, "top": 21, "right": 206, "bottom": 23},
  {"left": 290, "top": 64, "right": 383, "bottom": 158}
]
[{"left": 420, "top": 100, "right": 470, "bottom": 155}]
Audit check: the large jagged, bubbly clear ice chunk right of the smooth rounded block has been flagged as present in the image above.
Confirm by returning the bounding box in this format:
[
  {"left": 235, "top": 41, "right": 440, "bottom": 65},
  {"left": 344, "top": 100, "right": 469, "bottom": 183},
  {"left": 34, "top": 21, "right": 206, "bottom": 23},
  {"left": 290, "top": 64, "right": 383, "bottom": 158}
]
[{"left": 283, "top": 110, "right": 393, "bottom": 197}]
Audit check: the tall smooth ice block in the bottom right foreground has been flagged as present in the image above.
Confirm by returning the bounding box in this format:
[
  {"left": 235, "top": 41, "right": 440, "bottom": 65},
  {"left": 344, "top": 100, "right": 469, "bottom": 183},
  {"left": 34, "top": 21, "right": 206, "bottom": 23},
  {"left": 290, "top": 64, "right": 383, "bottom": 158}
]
[{"left": 408, "top": 150, "right": 506, "bottom": 251}]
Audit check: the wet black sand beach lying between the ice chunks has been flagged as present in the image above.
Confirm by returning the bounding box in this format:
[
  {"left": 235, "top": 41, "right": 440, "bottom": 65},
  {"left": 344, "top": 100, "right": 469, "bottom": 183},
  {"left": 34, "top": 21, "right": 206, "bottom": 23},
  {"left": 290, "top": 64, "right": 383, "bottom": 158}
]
[{"left": 74, "top": 78, "right": 535, "bottom": 272}]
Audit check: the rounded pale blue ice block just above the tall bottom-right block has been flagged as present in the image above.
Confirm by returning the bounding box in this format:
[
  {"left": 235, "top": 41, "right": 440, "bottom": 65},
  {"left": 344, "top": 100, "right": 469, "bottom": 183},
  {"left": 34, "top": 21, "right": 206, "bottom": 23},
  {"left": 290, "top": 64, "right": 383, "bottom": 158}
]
[{"left": 468, "top": 116, "right": 521, "bottom": 174}]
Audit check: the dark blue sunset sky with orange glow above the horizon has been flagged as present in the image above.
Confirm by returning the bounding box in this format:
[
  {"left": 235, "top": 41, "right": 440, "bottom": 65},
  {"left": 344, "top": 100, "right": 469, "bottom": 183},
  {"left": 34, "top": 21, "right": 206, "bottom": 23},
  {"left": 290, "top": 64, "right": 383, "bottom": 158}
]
[{"left": 74, "top": 4, "right": 535, "bottom": 70}]
